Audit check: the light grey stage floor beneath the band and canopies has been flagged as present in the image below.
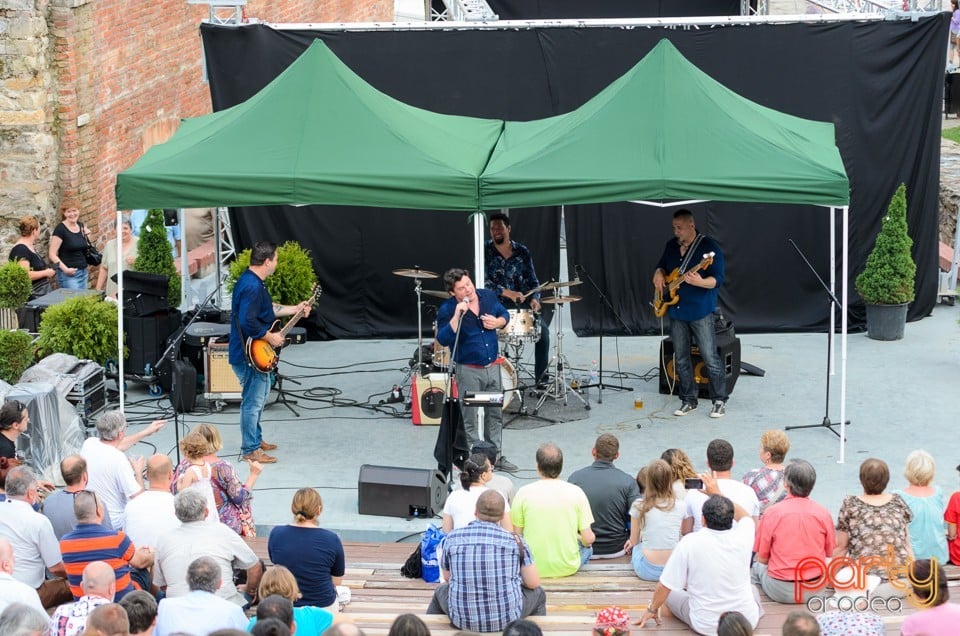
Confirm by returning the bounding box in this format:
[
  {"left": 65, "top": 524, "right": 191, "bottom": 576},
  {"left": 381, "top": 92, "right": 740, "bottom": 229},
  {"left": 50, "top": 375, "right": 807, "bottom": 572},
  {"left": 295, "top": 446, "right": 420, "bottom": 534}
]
[{"left": 116, "top": 301, "right": 960, "bottom": 541}]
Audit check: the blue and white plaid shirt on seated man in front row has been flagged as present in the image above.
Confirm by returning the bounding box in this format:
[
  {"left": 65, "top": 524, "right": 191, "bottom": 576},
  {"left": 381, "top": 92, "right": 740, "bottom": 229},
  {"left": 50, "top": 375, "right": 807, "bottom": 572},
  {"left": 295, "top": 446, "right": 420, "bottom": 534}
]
[{"left": 443, "top": 520, "right": 533, "bottom": 632}]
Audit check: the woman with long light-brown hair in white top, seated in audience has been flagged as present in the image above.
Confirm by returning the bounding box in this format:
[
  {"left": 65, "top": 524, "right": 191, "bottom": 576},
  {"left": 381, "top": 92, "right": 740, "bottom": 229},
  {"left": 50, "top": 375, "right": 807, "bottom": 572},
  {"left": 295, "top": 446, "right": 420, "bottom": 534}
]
[{"left": 625, "top": 459, "right": 686, "bottom": 581}]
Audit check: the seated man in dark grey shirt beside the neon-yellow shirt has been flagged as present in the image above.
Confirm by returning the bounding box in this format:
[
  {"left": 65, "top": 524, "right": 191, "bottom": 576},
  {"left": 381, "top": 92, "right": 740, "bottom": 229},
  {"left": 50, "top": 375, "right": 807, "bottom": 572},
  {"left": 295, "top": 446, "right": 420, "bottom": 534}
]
[{"left": 567, "top": 433, "right": 640, "bottom": 559}]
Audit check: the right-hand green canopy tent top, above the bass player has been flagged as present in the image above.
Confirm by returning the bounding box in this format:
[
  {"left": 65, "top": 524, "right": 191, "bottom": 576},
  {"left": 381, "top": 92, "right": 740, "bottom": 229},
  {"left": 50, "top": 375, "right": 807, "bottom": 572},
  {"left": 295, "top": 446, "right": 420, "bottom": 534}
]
[{"left": 480, "top": 40, "right": 850, "bottom": 209}]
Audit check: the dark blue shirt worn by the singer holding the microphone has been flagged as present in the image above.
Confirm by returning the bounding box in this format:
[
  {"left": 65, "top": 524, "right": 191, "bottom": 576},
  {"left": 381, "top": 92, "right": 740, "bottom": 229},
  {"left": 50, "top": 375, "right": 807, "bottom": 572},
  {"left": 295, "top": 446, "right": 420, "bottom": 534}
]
[{"left": 437, "top": 289, "right": 510, "bottom": 367}]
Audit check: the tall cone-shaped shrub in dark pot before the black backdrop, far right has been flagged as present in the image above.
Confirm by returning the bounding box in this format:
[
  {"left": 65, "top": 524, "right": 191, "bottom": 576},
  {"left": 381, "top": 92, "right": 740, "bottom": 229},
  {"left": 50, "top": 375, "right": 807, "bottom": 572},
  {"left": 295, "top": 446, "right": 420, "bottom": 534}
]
[{"left": 856, "top": 183, "right": 917, "bottom": 340}]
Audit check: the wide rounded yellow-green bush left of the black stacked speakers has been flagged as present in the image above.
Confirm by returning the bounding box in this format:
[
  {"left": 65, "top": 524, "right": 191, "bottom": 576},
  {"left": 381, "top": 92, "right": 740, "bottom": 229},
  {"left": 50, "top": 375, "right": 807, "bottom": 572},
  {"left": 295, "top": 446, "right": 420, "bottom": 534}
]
[{"left": 37, "top": 295, "right": 117, "bottom": 364}]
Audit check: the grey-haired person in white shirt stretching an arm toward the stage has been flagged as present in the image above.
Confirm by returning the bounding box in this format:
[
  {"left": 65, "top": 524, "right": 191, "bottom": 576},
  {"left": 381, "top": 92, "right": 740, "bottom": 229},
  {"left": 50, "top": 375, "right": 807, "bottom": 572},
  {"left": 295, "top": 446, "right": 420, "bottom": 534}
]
[{"left": 80, "top": 411, "right": 167, "bottom": 528}]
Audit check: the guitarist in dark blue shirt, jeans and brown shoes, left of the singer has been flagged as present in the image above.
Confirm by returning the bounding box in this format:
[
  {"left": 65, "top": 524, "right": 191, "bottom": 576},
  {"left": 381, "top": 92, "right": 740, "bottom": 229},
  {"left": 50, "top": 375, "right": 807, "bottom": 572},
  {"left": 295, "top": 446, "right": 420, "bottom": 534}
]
[{"left": 230, "top": 241, "right": 311, "bottom": 464}]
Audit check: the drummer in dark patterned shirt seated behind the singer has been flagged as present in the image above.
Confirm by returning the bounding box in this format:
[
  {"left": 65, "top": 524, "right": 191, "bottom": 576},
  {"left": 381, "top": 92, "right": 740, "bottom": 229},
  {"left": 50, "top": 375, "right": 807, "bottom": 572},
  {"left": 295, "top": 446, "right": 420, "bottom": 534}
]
[{"left": 484, "top": 212, "right": 550, "bottom": 386}]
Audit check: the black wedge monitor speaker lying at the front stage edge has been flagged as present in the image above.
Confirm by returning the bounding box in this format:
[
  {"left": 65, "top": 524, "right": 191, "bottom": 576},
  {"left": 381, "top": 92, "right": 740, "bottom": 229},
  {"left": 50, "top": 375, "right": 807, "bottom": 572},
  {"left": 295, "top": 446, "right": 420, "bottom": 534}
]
[{"left": 357, "top": 464, "right": 447, "bottom": 518}]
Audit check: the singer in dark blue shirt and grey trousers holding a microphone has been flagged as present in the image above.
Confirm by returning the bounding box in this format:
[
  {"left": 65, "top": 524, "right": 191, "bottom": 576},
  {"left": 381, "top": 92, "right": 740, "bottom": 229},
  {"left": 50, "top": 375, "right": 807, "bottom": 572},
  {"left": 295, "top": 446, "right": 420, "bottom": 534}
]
[{"left": 437, "top": 267, "right": 517, "bottom": 473}]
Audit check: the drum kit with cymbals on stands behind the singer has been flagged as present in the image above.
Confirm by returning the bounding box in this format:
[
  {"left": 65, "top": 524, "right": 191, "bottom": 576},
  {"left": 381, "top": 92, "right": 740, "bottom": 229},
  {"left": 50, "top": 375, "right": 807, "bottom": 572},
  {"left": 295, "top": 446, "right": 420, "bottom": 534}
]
[{"left": 393, "top": 266, "right": 590, "bottom": 417}]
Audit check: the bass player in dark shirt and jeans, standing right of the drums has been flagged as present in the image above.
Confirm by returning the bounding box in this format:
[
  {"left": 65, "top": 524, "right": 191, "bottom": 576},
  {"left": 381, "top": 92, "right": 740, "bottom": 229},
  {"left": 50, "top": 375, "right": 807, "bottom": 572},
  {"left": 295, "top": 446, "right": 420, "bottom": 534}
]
[{"left": 653, "top": 209, "right": 728, "bottom": 417}]
